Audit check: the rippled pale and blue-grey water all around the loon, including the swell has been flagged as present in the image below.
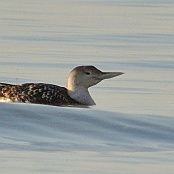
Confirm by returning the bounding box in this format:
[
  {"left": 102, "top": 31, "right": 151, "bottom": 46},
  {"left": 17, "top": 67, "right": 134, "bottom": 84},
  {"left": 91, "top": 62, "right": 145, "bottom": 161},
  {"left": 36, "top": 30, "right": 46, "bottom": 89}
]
[{"left": 0, "top": 0, "right": 174, "bottom": 173}]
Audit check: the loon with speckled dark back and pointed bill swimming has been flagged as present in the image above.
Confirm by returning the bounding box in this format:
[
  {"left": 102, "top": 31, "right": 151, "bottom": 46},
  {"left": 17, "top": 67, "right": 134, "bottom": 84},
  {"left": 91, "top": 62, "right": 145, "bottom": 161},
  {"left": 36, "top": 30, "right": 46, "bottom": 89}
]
[{"left": 0, "top": 66, "right": 124, "bottom": 106}]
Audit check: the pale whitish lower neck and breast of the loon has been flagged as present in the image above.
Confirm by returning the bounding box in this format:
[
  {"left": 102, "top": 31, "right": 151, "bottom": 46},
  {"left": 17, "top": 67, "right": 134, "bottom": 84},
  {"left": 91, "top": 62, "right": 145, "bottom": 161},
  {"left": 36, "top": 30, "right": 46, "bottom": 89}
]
[{"left": 67, "top": 86, "right": 96, "bottom": 106}]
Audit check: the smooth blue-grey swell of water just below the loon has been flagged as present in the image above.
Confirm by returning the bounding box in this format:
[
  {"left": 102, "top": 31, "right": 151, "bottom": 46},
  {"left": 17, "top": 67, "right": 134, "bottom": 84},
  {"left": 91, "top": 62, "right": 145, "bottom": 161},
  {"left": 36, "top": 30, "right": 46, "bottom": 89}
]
[{"left": 0, "top": 103, "right": 174, "bottom": 152}]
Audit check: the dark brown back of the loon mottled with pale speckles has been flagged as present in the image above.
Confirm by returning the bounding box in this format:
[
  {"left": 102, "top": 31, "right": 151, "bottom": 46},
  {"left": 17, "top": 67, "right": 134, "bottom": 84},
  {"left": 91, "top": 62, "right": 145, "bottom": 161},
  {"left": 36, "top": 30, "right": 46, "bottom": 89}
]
[{"left": 0, "top": 83, "right": 79, "bottom": 106}]
